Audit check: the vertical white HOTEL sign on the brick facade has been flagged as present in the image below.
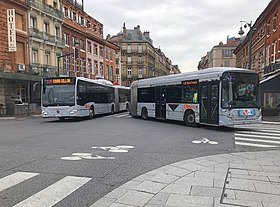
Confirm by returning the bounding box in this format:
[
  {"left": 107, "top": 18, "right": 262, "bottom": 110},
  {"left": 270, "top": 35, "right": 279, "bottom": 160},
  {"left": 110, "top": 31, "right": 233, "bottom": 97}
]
[{"left": 7, "top": 9, "right": 17, "bottom": 52}]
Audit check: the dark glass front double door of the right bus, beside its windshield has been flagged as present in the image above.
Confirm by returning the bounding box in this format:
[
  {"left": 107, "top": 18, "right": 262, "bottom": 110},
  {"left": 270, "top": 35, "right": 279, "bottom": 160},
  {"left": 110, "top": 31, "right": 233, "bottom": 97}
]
[{"left": 199, "top": 81, "right": 219, "bottom": 125}]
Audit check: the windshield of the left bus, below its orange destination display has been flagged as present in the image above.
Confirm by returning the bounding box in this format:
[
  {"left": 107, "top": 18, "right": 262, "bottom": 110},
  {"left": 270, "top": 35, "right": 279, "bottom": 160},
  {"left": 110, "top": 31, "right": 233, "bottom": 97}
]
[{"left": 42, "top": 84, "right": 75, "bottom": 107}]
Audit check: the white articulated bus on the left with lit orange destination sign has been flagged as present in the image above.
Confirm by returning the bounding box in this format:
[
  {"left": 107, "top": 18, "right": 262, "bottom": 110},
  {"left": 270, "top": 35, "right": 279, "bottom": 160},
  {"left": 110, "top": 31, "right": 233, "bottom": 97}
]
[{"left": 41, "top": 77, "right": 130, "bottom": 120}]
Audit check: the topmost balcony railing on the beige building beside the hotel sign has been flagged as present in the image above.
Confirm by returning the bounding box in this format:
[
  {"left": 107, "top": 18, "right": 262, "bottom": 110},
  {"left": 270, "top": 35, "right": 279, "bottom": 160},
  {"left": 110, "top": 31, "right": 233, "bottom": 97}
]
[{"left": 28, "top": 0, "right": 64, "bottom": 19}]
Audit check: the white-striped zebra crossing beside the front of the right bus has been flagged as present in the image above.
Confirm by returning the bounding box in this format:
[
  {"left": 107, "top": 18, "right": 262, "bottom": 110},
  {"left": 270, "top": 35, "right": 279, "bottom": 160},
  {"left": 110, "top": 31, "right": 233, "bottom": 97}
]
[{"left": 234, "top": 124, "right": 280, "bottom": 148}]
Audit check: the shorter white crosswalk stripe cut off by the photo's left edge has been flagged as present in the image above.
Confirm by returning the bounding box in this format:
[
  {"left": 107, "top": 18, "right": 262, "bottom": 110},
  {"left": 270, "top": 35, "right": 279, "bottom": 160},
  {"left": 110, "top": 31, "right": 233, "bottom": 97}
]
[{"left": 0, "top": 172, "right": 39, "bottom": 192}]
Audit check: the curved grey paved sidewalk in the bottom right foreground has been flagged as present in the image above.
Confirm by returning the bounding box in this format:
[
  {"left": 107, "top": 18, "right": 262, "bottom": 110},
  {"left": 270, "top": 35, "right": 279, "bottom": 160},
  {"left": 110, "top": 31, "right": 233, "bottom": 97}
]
[{"left": 91, "top": 150, "right": 280, "bottom": 207}]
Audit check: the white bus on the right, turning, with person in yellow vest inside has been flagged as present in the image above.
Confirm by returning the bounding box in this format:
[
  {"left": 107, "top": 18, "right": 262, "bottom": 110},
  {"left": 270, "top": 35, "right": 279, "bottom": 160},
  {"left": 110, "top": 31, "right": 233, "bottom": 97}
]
[{"left": 130, "top": 67, "right": 262, "bottom": 126}]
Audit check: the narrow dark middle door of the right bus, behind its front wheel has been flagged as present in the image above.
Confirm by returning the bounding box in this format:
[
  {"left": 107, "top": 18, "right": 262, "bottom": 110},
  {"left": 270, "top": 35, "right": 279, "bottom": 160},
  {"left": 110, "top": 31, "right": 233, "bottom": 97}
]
[{"left": 156, "top": 87, "right": 166, "bottom": 119}]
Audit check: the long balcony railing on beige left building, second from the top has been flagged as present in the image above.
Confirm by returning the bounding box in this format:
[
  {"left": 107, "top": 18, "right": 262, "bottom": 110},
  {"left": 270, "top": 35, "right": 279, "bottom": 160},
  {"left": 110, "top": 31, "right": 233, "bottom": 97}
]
[{"left": 29, "top": 28, "right": 65, "bottom": 47}]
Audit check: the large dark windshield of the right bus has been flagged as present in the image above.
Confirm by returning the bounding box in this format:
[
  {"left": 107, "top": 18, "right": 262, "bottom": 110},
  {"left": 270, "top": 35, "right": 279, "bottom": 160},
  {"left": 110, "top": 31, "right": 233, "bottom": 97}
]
[{"left": 222, "top": 72, "right": 259, "bottom": 108}]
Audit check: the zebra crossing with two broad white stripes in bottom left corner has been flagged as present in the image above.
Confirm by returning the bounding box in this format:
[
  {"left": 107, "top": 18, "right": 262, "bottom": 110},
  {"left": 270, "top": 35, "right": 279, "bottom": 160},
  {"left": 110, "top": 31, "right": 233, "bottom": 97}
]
[{"left": 0, "top": 172, "right": 92, "bottom": 207}]
